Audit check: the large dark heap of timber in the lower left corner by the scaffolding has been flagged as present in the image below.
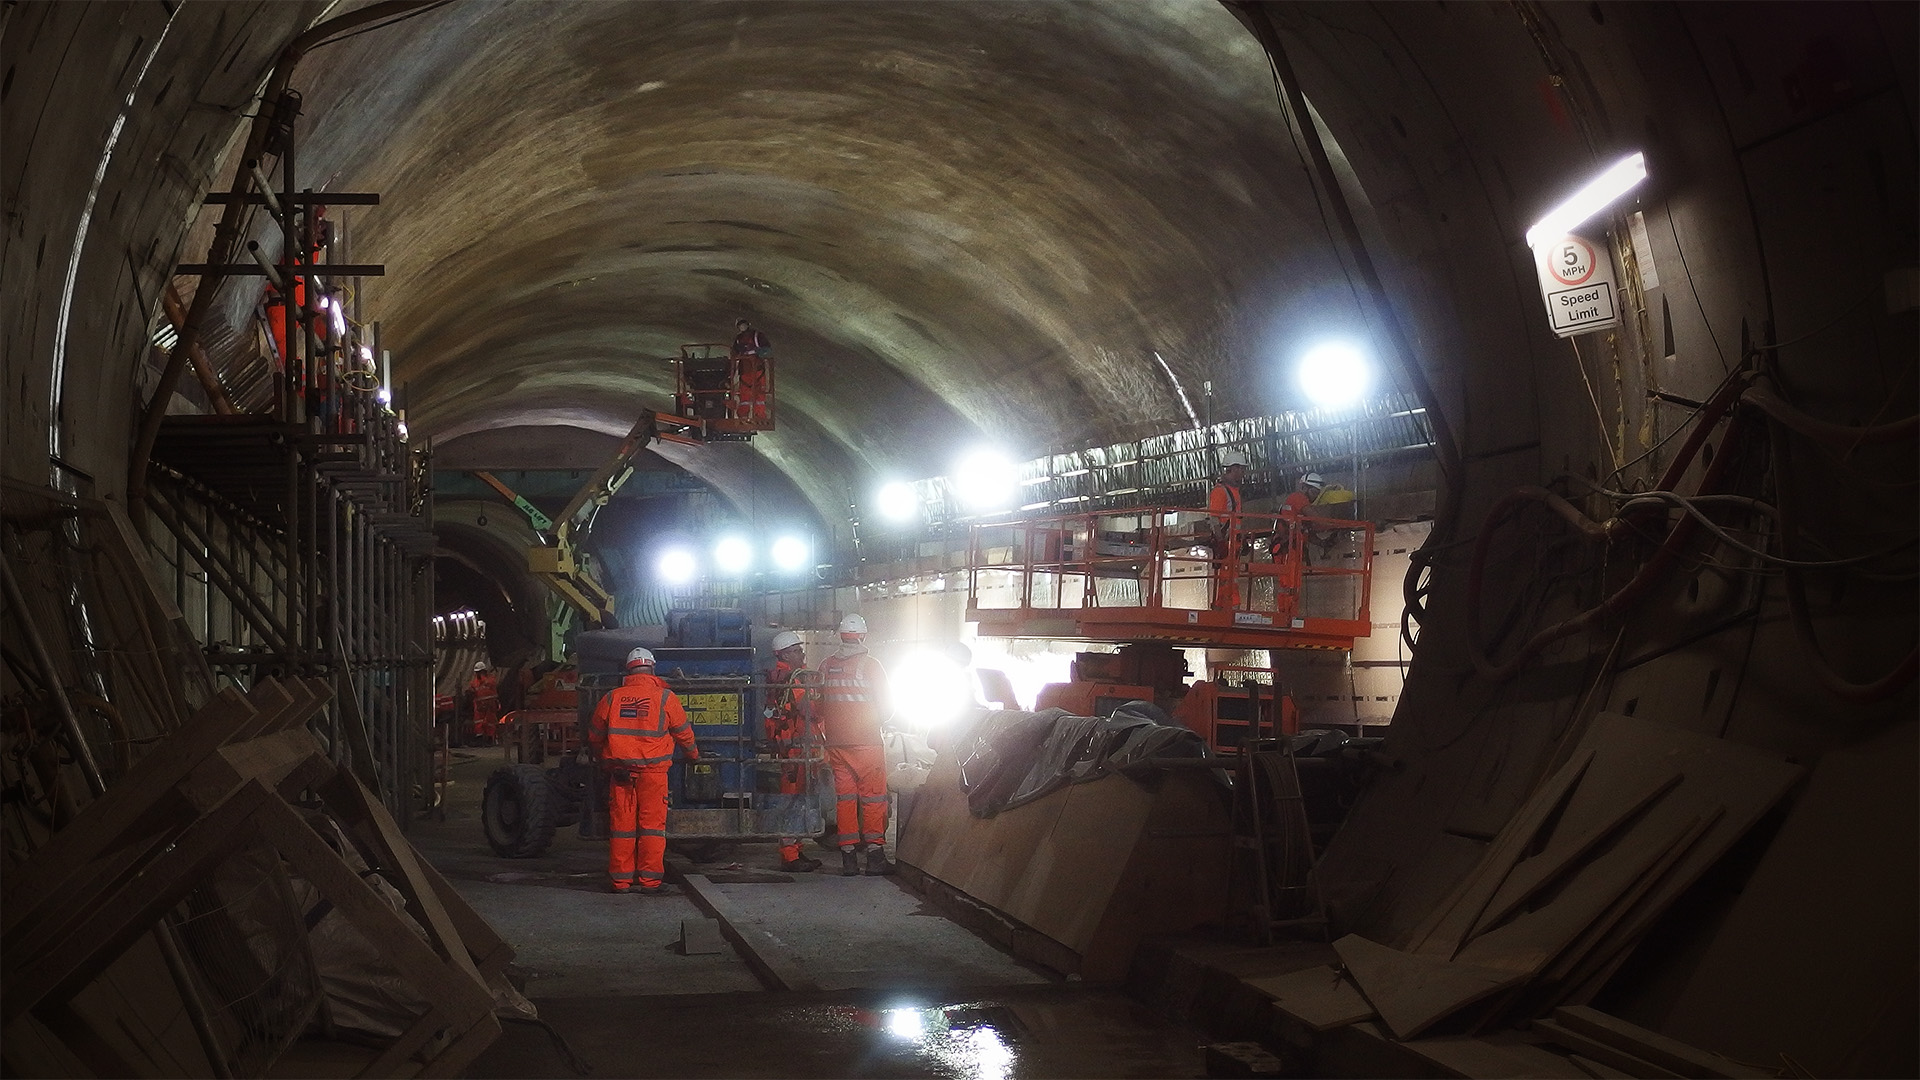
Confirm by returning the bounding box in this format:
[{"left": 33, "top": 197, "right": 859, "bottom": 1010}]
[{"left": 0, "top": 482, "right": 532, "bottom": 1078}]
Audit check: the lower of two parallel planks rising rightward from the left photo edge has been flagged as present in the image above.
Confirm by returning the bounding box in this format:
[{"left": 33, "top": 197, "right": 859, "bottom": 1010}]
[{"left": 0, "top": 782, "right": 272, "bottom": 1024}]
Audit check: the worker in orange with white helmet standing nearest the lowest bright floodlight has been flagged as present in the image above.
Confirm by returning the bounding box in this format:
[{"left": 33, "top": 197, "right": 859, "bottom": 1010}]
[{"left": 820, "top": 615, "right": 893, "bottom": 878}]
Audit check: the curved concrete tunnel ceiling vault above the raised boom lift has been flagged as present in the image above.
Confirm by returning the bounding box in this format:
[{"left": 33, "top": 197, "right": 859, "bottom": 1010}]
[{"left": 280, "top": 0, "right": 1357, "bottom": 521}]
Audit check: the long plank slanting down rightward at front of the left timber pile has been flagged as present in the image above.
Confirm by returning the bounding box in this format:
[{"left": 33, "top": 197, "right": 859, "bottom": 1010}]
[{"left": 257, "top": 799, "right": 493, "bottom": 1022}]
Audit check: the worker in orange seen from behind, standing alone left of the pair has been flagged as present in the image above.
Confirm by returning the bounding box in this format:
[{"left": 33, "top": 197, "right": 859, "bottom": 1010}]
[{"left": 588, "top": 650, "right": 701, "bottom": 896}]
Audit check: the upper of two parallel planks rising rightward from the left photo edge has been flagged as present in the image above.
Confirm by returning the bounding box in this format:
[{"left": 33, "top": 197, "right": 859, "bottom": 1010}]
[{"left": 0, "top": 690, "right": 253, "bottom": 937}]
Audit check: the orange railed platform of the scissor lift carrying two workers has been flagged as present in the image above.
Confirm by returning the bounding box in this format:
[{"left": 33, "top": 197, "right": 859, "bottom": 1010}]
[{"left": 966, "top": 507, "right": 1373, "bottom": 650}]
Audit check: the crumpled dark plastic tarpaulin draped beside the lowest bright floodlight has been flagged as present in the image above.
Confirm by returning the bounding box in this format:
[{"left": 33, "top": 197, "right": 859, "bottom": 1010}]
[{"left": 952, "top": 701, "right": 1208, "bottom": 817}]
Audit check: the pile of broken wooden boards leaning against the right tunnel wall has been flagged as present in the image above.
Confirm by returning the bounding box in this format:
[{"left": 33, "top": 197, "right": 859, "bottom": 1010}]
[{"left": 1261, "top": 713, "right": 1803, "bottom": 1078}]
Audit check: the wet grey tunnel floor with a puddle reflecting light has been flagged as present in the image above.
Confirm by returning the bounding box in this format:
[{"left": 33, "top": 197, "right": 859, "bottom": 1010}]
[{"left": 426, "top": 749, "right": 1206, "bottom": 1080}]
